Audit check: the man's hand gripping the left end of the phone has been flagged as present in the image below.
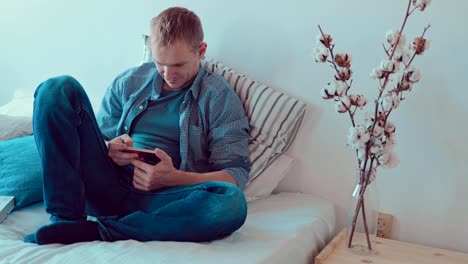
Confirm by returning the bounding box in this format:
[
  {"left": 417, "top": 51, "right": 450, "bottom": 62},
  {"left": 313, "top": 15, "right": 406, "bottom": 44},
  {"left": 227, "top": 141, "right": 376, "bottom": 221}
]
[{"left": 107, "top": 134, "right": 138, "bottom": 166}]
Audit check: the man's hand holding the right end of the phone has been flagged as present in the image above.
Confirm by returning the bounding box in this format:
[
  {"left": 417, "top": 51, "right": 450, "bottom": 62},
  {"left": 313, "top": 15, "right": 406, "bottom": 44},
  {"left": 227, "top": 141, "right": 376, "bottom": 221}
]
[{"left": 131, "top": 148, "right": 177, "bottom": 191}]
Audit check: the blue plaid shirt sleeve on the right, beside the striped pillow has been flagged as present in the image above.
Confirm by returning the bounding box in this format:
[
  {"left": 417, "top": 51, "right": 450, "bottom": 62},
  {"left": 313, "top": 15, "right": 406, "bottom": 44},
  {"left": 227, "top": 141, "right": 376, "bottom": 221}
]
[{"left": 209, "top": 84, "right": 251, "bottom": 189}]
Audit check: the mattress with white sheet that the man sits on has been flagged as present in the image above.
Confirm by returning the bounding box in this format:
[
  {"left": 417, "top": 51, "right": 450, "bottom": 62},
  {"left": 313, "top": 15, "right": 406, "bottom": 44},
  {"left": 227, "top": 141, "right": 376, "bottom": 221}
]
[{"left": 0, "top": 193, "right": 335, "bottom": 264}]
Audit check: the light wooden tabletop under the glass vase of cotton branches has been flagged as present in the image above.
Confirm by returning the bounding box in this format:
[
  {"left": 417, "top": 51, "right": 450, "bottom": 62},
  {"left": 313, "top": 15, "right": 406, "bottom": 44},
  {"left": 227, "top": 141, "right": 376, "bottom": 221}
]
[{"left": 315, "top": 230, "right": 468, "bottom": 264}]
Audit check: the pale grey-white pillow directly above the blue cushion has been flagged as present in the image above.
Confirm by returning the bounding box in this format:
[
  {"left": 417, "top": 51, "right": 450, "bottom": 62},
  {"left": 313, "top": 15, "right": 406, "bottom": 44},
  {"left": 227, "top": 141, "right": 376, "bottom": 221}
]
[{"left": 0, "top": 114, "right": 32, "bottom": 141}]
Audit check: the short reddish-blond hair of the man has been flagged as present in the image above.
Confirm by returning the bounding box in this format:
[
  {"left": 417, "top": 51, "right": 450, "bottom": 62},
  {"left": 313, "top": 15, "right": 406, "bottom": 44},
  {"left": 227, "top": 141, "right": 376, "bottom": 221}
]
[{"left": 151, "top": 7, "right": 203, "bottom": 50}]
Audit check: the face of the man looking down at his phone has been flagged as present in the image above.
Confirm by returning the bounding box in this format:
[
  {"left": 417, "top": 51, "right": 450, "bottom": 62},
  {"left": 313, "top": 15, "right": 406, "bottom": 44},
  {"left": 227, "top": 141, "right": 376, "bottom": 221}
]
[{"left": 151, "top": 41, "right": 206, "bottom": 90}]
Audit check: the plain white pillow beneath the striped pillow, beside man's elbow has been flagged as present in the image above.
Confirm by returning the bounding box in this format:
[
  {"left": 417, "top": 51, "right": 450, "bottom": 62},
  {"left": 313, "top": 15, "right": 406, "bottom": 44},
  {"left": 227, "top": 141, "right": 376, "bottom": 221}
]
[{"left": 244, "top": 154, "right": 294, "bottom": 202}]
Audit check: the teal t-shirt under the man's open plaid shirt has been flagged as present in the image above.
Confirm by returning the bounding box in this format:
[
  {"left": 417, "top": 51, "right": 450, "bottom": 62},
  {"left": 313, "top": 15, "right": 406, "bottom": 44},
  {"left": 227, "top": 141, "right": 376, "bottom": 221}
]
[{"left": 130, "top": 89, "right": 188, "bottom": 168}]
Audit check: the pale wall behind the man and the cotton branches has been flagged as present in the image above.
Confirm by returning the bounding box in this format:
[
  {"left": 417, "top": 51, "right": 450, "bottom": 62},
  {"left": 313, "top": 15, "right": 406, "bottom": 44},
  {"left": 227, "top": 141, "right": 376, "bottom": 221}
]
[{"left": 0, "top": 0, "right": 468, "bottom": 252}]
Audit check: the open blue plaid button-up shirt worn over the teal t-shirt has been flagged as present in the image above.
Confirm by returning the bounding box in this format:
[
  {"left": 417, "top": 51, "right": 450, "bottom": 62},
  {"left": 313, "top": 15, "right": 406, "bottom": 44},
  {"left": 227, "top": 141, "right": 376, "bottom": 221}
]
[{"left": 97, "top": 62, "right": 250, "bottom": 189}]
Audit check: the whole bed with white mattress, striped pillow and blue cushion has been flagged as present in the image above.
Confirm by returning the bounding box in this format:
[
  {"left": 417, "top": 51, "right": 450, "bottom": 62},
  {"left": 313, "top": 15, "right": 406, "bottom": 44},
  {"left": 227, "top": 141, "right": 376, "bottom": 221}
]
[{"left": 0, "top": 43, "right": 335, "bottom": 264}]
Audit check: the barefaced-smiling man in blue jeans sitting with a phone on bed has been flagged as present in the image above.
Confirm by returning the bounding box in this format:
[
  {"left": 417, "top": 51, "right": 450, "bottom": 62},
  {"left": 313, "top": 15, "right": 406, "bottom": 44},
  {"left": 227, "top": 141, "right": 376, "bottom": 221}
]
[{"left": 25, "top": 8, "right": 250, "bottom": 244}]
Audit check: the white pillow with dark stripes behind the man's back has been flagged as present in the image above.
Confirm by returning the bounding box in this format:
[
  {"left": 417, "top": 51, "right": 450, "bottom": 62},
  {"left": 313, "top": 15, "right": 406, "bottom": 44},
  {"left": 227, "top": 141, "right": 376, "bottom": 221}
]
[{"left": 142, "top": 35, "right": 306, "bottom": 186}]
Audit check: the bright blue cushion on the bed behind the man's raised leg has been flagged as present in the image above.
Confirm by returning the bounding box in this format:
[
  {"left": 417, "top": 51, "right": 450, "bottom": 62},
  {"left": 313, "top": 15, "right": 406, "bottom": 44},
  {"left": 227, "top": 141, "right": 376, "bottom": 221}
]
[{"left": 0, "top": 136, "right": 42, "bottom": 210}]
